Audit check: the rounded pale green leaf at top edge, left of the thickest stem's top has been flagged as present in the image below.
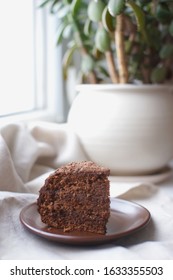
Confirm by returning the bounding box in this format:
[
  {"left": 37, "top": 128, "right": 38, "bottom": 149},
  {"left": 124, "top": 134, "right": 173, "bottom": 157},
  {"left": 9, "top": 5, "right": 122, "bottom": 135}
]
[{"left": 88, "top": 0, "right": 105, "bottom": 22}]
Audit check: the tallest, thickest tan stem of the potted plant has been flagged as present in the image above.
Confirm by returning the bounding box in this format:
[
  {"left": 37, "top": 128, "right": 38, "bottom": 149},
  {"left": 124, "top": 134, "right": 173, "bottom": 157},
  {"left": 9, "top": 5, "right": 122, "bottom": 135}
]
[{"left": 115, "top": 14, "right": 128, "bottom": 84}]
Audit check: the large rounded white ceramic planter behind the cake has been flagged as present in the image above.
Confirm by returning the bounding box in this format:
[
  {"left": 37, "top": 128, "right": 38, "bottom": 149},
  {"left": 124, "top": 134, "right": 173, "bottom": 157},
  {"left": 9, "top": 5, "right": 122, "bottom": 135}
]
[{"left": 68, "top": 85, "right": 173, "bottom": 175}]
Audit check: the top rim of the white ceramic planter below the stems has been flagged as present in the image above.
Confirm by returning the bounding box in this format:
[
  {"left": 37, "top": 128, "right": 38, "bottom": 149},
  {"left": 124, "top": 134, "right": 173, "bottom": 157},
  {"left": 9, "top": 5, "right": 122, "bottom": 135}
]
[{"left": 76, "top": 84, "right": 173, "bottom": 91}]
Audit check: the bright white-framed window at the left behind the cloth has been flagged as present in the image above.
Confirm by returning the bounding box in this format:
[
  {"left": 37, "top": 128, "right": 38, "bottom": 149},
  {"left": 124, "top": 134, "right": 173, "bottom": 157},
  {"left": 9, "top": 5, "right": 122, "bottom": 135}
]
[{"left": 0, "top": 0, "right": 64, "bottom": 121}]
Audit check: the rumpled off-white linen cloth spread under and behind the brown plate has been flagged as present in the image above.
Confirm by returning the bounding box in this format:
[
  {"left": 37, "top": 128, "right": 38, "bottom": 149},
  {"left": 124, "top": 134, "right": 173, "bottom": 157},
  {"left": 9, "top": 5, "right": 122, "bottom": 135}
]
[{"left": 0, "top": 122, "right": 173, "bottom": 260}]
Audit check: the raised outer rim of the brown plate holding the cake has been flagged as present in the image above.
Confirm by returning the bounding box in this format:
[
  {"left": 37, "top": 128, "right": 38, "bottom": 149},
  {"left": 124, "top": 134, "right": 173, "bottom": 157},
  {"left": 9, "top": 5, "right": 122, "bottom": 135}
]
[{"left": 19, "top": 197, "right": 151, "bottom": 245}]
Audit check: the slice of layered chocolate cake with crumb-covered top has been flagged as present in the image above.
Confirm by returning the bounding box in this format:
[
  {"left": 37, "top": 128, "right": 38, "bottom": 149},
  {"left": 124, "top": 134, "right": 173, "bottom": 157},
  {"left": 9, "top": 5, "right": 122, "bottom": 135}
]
[{"left": 37, "top": 161, "right": 110, "bottom": 234}]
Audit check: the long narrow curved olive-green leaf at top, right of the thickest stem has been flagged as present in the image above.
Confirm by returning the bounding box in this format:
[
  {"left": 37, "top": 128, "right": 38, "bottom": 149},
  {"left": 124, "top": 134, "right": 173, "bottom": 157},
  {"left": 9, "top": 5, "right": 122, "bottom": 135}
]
[{"left": 127, "top": 0, "right": 145, "bottom": 31}]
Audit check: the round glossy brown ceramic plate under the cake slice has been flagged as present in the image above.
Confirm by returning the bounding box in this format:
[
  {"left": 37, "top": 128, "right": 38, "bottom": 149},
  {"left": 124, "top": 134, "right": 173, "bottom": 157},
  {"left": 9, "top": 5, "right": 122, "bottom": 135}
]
[{"left": 20, "top": 198, "right": 150, "bottom": 245}]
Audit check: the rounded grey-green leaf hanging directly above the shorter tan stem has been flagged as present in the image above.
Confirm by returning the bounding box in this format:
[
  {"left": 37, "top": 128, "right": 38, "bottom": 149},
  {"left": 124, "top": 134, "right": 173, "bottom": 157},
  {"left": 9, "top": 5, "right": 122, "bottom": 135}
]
[{"left": 95, "top": 27, "right": 110, "bottom": 52}]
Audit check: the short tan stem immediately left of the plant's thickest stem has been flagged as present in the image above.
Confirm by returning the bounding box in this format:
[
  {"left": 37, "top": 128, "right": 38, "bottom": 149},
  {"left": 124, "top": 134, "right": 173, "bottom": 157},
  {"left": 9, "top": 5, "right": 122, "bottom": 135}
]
[{"left": 105, "top": 51, "right": 119, "bottom": 84}]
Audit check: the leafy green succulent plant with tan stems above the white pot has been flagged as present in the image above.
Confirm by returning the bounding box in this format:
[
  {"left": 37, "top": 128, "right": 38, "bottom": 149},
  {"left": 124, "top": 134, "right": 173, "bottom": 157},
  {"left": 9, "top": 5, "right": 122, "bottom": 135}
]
[{"left": 41, "top": 0, "right": 173, "bottom": 83}]
